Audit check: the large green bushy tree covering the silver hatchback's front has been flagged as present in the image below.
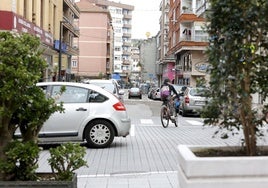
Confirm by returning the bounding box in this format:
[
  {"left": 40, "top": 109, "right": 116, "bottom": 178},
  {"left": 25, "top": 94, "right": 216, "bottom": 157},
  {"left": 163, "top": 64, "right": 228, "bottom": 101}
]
[{"left": 0, "top": 32, "right": 62, "bottom": 180}]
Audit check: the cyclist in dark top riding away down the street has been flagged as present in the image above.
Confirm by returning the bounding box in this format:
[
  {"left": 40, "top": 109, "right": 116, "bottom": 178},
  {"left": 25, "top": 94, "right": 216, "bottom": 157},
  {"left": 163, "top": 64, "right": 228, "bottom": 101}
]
[{"left": 160, "top": 78, "right": 179, "bottom": 119}]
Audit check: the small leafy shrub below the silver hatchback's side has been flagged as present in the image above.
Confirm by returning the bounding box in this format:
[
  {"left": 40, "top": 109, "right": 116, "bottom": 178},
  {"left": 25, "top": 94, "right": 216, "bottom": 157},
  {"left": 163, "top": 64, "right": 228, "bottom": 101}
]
[{"left": 48, "top": 143, "right": 87, "bottom": 180}]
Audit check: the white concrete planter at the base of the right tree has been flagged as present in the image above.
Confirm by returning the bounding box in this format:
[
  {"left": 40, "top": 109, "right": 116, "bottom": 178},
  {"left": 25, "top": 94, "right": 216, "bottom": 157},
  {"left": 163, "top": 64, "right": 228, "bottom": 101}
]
[{"left": 178, "top": 145, "right": 268, "bottom": 188}]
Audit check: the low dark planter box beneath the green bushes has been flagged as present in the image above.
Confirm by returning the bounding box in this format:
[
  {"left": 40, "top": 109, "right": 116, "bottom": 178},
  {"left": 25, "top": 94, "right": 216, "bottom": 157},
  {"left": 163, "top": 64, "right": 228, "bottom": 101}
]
[{"left": 0, "top": 173, "right": 77, "bottom": 188}]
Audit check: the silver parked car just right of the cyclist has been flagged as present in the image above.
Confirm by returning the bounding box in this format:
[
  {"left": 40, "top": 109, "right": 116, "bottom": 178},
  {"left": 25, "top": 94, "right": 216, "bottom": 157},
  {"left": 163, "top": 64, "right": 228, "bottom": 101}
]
[{"left": 179, "top": 87, "right": 207, "bottom": 116}]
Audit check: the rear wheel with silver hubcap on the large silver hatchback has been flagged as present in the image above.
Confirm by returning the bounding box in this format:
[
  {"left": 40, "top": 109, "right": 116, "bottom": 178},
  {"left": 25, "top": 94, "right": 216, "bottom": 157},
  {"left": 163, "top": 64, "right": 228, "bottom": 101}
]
[{"left": 85, "top": 120, "right": 115, "bottom": 148}]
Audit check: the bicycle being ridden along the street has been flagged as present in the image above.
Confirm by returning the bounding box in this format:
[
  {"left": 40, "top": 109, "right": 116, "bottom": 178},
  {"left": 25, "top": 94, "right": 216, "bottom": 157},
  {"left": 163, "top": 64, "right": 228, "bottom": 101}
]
[{"left": 160, "top": 96, "right": 178, "bottom": 128}]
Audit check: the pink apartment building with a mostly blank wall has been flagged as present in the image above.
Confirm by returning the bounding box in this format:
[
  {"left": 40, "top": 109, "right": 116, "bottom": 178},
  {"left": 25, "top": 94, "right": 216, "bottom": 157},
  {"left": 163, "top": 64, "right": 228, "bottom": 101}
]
[{"left": 75, "top": 0, "right": 113, "bottom": 79}]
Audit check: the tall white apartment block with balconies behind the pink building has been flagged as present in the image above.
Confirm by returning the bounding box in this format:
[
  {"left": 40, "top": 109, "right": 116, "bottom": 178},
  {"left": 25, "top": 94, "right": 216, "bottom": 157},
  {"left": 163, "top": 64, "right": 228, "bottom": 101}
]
[{"left": 89, "top": 0, "right": 134, "bottom": 81}]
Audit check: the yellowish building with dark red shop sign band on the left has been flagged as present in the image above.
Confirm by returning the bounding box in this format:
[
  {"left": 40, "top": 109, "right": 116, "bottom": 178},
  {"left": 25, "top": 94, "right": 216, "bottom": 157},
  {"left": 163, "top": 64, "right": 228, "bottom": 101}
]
[{"left": 0, "top": 0, "right": 79, "bottom": 81}]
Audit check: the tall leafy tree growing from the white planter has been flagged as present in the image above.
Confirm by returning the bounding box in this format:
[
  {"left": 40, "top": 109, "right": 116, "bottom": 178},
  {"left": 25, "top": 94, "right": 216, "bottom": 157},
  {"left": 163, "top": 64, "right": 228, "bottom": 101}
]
[{"left": 203, "top": 0, "right": 268, "bottom": 156}]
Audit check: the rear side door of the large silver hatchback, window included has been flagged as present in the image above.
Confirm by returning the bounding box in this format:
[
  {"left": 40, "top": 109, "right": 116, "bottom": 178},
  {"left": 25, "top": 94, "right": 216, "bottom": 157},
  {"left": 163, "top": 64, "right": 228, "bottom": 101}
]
[{"left": 43, "top": 85, "right": 90, "bottom": 139}]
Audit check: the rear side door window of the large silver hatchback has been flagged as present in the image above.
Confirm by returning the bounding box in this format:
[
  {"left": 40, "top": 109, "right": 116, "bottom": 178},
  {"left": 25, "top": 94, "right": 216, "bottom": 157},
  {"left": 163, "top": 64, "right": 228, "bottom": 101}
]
[{"left": 51, "top": 86, "right": 88, "bottom": 103}]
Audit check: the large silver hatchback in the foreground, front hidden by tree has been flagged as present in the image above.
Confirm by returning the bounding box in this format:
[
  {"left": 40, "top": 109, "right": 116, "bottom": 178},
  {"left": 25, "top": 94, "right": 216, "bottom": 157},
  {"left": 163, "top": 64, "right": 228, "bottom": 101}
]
[{"left": 16, "top": 82, "right": 131, "bottom": 148}]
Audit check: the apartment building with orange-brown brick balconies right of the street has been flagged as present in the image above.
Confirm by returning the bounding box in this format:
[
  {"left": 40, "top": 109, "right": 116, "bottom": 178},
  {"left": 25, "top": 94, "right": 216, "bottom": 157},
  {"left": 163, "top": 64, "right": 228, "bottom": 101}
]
[{"left": 166, "top": 0, "right": 209, "bottom": 86}]
